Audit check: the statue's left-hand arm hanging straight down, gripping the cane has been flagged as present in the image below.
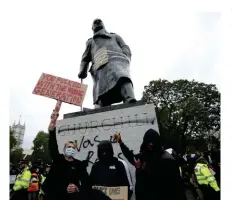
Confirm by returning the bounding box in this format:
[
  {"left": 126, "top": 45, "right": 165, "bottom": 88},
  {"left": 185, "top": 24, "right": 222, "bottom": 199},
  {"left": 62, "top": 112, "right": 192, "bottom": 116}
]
[{"left": 78, "top": 39, "right": 92, "bottom": 79}]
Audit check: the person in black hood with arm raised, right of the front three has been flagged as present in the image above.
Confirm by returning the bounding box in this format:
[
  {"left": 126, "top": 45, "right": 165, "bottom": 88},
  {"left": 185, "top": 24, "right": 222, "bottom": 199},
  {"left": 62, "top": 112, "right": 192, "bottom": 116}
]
[{"left": 115, "top": 129, "right": 184, "bottom": 200}]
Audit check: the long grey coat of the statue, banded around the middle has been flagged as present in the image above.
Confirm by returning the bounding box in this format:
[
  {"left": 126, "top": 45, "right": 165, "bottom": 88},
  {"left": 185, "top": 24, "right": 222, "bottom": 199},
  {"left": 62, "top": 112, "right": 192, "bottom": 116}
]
[{"left": 80, "top": 29, "right": 131, "bottom": 104}]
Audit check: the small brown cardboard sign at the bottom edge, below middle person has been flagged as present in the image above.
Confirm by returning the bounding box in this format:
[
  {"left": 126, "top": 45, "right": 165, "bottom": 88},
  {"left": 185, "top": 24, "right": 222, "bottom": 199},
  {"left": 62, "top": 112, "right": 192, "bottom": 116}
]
[{"left": 93, "top": 186, "right": 128, "bottom": 200}]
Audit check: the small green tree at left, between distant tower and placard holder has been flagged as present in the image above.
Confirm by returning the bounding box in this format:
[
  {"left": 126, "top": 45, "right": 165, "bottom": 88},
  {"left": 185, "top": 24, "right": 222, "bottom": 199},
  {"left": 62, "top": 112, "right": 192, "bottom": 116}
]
[{"left": 31, "top": 131, "right": 51, "bottom": 163}]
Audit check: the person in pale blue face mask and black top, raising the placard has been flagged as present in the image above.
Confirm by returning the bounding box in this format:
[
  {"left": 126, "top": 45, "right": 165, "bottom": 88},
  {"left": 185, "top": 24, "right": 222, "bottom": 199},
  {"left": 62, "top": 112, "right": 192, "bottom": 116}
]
[{"left": 42, "top": 111, "right": 90, "bottom": 200}]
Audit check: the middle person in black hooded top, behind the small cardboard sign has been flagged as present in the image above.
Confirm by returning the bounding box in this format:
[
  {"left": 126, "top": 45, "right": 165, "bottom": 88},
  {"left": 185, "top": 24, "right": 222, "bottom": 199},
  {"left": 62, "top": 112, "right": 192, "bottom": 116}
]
[{"left": 90, "top": 140, "right": 133, "bottom": 199}]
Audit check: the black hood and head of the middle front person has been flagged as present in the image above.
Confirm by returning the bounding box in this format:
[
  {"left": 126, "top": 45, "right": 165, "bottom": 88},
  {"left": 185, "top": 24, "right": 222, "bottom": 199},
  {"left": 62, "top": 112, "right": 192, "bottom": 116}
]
[{"left": 97, "top": 140, "right": 114, "bottom": 162}]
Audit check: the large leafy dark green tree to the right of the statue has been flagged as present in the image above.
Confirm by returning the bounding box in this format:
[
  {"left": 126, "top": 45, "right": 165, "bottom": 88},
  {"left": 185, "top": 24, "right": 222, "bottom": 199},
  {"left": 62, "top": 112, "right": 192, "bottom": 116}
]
[{"left": 142, "top": 79, "right": 220, "bottom": 150}]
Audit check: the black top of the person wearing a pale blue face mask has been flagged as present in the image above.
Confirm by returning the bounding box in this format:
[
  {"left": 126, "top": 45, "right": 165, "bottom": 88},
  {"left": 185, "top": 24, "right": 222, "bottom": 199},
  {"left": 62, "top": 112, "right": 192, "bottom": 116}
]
[{"left": 43, "top": 131, "right": 90, "bottom": 200}]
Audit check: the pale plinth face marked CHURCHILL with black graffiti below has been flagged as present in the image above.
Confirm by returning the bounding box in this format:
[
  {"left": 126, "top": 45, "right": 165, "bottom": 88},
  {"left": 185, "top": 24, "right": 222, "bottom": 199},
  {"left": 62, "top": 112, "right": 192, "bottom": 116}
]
[{"left": 56, "top": 104, "right": 158, "bottom": 171}]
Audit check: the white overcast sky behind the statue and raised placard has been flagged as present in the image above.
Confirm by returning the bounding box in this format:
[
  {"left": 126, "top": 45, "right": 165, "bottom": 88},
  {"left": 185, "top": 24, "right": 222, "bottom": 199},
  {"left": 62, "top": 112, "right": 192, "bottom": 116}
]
[{"left": 6, "top": 0, "right": 222, "bottom": 148}]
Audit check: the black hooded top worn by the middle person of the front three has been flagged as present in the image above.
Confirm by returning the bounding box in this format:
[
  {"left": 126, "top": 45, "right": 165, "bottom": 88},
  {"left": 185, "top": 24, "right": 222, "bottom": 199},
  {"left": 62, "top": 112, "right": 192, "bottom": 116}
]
[{"left": 90, "top": 141, "right": 133, "bottom": 198}]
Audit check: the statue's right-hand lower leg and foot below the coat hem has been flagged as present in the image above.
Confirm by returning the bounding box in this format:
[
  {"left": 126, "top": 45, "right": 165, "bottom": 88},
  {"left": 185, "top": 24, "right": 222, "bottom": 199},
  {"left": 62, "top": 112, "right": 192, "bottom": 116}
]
[{"left": 121, "top": 82, "right": 136, "bottom": 103}]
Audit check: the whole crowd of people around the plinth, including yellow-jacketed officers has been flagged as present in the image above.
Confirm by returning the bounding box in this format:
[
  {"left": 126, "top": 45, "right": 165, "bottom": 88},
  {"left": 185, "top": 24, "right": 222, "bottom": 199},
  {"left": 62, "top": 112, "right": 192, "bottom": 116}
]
[{"left": 10, "top": 112, "right": 220, "bottom": 200}]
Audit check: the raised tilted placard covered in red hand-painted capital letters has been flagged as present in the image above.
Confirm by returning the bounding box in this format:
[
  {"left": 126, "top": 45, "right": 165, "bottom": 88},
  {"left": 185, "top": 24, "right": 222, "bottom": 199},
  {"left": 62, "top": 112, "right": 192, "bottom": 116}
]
[{"left": 33, "top": 73, "right": 87, "bottom": 106}]
